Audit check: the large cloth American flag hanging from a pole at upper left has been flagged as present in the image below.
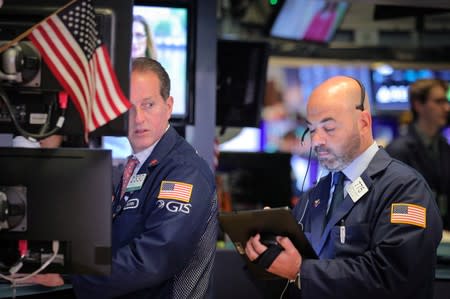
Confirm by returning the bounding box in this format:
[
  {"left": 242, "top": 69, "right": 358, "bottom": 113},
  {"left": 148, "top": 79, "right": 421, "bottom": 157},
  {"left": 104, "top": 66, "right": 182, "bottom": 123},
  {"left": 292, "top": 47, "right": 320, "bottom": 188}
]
[{"left": 29, "top": 0, "right": 131, "bottom": 132}]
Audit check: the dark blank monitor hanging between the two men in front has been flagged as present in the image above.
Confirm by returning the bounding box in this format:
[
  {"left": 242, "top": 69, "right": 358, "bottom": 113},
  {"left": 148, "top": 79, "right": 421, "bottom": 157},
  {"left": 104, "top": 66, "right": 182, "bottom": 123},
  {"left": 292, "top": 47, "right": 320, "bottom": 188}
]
[{"left": 216, "top": 39, "right": 269, "bottom": 127}]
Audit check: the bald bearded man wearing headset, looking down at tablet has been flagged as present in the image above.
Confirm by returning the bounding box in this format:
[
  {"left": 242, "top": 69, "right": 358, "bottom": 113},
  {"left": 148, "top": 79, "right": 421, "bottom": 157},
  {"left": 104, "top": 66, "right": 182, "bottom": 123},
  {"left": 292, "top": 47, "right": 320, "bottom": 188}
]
[{"left": 245, "top": 76, "right": 442, "bottom": 299}]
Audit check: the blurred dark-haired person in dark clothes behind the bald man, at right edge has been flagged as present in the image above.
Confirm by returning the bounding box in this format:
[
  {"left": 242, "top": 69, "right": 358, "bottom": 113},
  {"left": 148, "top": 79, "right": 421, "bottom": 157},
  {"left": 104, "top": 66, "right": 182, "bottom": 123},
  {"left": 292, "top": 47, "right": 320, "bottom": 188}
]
[{"left": 386, "top": 79, "right": 450, "bottom": 230}]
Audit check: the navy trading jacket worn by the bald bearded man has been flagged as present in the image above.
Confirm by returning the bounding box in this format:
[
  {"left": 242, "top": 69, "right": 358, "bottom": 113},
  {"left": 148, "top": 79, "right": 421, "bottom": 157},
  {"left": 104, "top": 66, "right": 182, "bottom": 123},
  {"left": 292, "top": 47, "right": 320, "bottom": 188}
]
[{"left": 290, "top": 149, "right": 442, "bottom": 299}]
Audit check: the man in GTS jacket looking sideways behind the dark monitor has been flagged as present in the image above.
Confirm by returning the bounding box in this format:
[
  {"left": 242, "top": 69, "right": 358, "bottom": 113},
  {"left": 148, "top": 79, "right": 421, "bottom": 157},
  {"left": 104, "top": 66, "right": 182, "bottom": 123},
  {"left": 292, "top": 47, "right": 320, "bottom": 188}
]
[{"left": 33, "top": 58, "right": 218, "bottom": 299}]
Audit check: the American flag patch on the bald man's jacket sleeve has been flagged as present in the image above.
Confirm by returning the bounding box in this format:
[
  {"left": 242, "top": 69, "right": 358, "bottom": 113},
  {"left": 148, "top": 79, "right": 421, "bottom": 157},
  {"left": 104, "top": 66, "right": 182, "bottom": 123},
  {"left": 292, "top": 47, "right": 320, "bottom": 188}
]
[{"left": 391, "top": 203, "right": 427, "bottom": 228}]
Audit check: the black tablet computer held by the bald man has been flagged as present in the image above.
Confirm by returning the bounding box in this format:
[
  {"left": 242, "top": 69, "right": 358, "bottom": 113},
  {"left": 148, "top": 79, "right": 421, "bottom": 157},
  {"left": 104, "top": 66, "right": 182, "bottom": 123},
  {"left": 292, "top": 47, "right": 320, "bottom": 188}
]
[{"left": 219, "top": 207, "right": 317, "bottom": 279}]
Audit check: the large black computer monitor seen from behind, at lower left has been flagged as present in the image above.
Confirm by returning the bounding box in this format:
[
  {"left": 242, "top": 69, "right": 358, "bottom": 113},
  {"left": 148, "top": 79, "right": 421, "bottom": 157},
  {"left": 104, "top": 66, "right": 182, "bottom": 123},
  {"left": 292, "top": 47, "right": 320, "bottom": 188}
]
[{"left": 0, "top": 147, "right": 112, "bottom": 275}]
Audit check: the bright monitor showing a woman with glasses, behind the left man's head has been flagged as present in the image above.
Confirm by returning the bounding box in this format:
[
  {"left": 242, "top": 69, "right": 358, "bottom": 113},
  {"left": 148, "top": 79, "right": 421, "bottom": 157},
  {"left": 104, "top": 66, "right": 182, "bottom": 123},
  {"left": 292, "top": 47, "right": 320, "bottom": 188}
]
[{"left": 131, "top": 1, "right": 194, "bottom": 123}]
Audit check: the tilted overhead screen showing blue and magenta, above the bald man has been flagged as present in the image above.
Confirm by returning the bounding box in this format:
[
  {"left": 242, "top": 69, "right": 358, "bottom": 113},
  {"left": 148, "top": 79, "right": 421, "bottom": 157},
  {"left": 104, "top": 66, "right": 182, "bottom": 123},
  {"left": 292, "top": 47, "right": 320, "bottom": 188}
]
[{"left": 270, "top": 0, "right": 349, "bottom": 43}]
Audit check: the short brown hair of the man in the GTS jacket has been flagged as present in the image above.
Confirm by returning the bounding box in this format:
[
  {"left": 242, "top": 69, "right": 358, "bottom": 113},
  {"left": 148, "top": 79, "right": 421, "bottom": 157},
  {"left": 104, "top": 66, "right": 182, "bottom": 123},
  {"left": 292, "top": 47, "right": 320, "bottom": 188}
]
[{"left": 131, "top": 57, "right": 170, "bottom": 100}]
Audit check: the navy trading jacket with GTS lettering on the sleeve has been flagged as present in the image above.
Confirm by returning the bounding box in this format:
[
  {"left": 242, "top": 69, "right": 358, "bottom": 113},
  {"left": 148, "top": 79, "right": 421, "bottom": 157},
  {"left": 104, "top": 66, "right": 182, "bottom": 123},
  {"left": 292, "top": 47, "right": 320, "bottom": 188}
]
[{"left": 72, "top": 127, "right": 218, "bottom": 299}]
